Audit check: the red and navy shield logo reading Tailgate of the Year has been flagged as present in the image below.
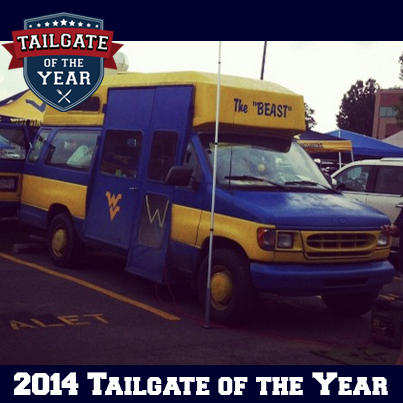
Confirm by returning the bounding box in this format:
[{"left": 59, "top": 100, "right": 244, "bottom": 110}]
[{"left": 3, "top": 13, "right": 123, "bottom": 112}]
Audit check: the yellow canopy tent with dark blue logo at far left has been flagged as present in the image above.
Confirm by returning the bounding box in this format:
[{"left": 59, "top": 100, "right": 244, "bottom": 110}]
[{"left": 0, "top": 90, "right": 46, "bottom": 126}]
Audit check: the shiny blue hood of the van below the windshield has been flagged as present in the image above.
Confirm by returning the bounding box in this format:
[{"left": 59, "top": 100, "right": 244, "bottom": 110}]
[{"left": 224, "top": 190, "right": 390, "bottom": 230}]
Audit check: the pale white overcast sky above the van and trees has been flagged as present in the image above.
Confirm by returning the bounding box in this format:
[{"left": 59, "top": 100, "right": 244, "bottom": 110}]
[{"left": 0, "top": 41, "right": 403, "bottom": 133}]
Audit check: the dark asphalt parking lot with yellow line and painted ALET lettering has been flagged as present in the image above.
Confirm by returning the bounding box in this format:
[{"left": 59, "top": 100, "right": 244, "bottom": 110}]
[{"left": 0, "top": 222, "right": 401, "bottom": 365}]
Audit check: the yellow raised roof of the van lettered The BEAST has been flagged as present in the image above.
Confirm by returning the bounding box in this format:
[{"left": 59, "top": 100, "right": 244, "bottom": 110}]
[{"left": 44, "top": 71, "right": 305, "bottom": 134}]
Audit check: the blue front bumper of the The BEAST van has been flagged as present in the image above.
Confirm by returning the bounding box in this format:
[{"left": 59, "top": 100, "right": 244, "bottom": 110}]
[{"left": 250, "top": 261, "right": 396, "bottom": 296}]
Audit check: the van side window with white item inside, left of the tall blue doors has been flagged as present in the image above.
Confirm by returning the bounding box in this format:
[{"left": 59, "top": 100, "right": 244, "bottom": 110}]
[{"left": 45, "top": 129, "right": 99, "bottom": 171}]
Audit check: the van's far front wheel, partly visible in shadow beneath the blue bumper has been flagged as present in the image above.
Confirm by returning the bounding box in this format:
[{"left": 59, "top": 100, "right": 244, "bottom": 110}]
[{"left": 322, "top": 291, "right": 378, "bottom": 317}]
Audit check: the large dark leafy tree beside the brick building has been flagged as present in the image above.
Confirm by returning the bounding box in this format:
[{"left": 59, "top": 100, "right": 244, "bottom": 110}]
[{"left": 336, "top": 78, "right": 379, "bottom": 136}]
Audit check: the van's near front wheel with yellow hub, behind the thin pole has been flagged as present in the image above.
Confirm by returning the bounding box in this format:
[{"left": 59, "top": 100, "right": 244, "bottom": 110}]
[{"left": 197, "top": 249, "right": 256, "bottom": 323}]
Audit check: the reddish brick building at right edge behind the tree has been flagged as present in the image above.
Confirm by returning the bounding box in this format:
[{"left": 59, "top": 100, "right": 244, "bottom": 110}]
[{"left": 372, "top": 88, "right": 403, "bottom": 140}]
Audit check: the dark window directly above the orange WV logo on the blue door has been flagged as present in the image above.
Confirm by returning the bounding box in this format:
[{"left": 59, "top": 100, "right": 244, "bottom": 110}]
[{"left": 101, "top": 130, "right": 142, "bottom": 178}]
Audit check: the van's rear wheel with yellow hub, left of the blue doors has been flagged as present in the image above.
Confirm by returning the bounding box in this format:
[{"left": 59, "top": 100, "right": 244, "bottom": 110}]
[{"left": 47, "top": 213, "right": 81, "bottom": 267}]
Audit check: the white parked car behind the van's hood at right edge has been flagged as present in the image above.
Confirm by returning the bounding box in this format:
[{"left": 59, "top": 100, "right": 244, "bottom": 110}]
[{"left": 332, "top": 158, "right": 403, "bottom": 266}]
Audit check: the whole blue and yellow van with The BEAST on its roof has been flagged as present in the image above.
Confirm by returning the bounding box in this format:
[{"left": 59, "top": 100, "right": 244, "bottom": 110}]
[{"left": 20, "top": 72, "right": 394, "bottom": 322}]
